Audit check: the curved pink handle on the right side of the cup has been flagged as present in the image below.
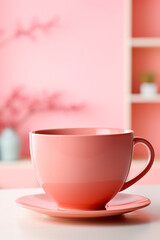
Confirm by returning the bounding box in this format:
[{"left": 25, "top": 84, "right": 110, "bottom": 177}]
[{"left": 120, "top": 137, "right": 155, "bottom": 191}]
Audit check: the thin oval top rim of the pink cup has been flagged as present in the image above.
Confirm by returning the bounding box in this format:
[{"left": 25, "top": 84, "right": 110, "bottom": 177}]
[{"left": 29, "top": 127, "right": 134, "bottom": 137}]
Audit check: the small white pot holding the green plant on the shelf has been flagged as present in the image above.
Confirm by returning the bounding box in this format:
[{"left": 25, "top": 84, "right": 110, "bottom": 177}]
[{"left": 140, "top": 82, "right": 158, "bottom": 97}]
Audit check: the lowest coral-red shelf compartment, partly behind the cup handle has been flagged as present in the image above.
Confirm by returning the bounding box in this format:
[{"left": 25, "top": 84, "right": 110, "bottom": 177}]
[{"left": 131, "top": 103, "right": 160, "bottom": 159}]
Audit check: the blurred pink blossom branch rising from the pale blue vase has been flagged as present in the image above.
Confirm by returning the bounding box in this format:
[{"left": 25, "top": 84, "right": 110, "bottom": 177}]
[{"left": 0, "top": 87, "right": 85, "bottom": 130}]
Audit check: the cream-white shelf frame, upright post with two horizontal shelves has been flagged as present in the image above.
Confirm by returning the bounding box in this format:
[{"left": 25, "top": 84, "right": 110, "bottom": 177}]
[{"left": 124, "top": 0, "right": 160, "bottom": 129}]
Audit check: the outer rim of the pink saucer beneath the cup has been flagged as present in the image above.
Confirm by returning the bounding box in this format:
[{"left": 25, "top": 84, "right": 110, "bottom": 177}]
[{"left": 15, "top": 193, "right": 151, "bottom": 219}]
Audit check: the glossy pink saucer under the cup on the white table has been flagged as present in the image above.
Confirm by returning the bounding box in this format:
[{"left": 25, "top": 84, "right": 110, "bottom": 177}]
[{"left": 16, "top": 193, "right": 151, "bottom": 219}]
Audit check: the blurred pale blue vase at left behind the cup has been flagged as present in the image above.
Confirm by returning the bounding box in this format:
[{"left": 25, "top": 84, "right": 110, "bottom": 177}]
[{"left": 0, "top": 128, "right": 20, "bottom": 162}]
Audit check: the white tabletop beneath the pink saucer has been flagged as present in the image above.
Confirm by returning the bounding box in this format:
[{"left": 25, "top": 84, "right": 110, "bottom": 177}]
[{"left": 0, "top": 185, "right": 160, "bottom": 240}]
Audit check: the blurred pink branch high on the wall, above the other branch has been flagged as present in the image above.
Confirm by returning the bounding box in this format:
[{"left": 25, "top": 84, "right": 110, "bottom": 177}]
[{"left": 0, "top": 17, "right": 58, "bottom": 48}]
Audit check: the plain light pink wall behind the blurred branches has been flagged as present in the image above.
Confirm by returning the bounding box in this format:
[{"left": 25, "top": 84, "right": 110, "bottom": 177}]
[{"left": 0, "top": 0, "right": 123, "bottom": 156}]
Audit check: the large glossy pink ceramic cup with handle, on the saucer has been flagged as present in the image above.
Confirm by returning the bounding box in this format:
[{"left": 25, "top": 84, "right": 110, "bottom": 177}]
[{"left": 30, "top": 128, "right": 154, "bottom": 210}]
